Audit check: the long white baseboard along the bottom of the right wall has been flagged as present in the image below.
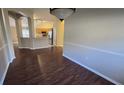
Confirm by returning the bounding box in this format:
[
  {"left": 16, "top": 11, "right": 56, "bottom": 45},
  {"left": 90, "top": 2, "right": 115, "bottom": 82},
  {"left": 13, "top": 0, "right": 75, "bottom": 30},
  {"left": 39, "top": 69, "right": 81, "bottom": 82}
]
[{"left": 63, "top": 54, "right": 122, "bottom": 85}]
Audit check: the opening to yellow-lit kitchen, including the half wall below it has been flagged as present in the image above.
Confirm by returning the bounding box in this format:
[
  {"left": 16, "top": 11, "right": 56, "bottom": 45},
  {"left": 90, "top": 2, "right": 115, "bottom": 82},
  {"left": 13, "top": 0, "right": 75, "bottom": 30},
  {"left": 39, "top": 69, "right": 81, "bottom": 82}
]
[{"left": 34, "top": 19, "right": 56, "bottom": 47}]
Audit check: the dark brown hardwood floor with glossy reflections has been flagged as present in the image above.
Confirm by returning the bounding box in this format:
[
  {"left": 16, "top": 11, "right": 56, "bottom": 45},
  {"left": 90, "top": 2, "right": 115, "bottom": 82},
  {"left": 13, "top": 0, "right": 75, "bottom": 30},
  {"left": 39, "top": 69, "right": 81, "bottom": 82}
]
[{"left": 4, "top": 47, "right": 113, "bottom": 85}]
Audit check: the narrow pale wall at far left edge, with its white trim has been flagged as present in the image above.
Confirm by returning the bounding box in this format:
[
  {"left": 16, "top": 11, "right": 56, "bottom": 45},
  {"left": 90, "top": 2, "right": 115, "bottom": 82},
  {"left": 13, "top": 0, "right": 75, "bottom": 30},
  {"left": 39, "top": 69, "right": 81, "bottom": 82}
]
[{"left": 0, "top": 9, "right": 15, "bottom": 84}]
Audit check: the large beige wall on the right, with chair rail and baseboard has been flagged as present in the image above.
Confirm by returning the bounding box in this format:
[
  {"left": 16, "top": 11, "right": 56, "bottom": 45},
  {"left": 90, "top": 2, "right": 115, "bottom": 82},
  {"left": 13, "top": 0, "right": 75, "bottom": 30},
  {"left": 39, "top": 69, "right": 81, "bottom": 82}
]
[{"left": 64, "top": 9, "right": 124, "bottom": 84}]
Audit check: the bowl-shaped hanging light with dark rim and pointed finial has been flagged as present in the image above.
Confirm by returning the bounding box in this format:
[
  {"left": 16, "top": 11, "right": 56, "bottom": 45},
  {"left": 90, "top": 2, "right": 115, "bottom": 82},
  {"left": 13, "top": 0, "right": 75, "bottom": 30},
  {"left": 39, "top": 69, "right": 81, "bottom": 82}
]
[{"left": 50, "top": 8, "right": 76, "bottom": 21}]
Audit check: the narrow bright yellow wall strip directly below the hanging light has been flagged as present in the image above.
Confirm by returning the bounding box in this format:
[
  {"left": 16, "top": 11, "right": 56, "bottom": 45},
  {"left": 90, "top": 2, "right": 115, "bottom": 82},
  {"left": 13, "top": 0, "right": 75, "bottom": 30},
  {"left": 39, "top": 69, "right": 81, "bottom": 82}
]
[{"left": 56, "top": 20, "right": 64, "bottom": 46}]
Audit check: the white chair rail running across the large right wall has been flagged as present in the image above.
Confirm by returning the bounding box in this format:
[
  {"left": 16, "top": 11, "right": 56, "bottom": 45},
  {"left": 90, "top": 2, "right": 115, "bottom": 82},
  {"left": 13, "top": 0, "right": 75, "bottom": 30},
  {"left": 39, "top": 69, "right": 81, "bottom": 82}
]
[{"left": 65, "top": 42, "right": 124, "bottom": 57}]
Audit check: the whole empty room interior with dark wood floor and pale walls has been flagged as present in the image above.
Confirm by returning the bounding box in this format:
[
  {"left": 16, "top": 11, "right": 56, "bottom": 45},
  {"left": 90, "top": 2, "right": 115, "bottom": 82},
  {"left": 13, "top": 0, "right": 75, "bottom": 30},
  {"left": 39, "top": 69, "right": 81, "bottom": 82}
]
[{"left": 0, "top": 8, "right": 124, "bottom": 85}]
